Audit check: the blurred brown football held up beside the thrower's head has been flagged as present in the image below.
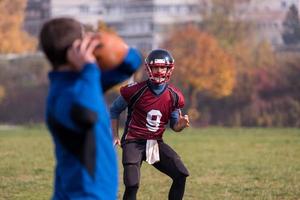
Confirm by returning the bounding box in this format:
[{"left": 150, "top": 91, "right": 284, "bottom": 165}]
[{"left": 94, "top": 32, "right": 129, "bottom": 70}]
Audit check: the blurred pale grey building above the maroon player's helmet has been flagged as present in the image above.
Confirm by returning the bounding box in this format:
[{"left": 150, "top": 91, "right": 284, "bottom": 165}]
[{"left": 103, "top": 0, "right": 206, "bottom": 51}]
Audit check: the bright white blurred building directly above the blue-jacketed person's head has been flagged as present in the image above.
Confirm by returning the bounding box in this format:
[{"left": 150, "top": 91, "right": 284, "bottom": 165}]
[{"left": 50, "top": 0, "right": 103, "bottom": 26}]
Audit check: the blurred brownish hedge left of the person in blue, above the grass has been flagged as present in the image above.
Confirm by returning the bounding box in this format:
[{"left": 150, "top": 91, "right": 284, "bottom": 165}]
[{"left": 0, "top": 54, "right": 50, "bottom": 124}]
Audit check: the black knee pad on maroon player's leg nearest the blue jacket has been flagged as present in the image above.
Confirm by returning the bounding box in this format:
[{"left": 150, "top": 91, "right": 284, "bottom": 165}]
[{"left": 124, "top": 164, "right": 140, "bottom": 187}]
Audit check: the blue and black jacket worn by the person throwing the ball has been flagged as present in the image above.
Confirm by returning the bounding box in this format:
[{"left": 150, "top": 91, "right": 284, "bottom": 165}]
[{"left": 46, "top": 49, "right": 142, "bottom": 200}]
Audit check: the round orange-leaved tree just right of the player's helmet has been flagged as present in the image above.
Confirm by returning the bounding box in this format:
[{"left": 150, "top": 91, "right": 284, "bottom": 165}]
[{"left": 163, "top": 25, "right": 236, "bottom": 119}]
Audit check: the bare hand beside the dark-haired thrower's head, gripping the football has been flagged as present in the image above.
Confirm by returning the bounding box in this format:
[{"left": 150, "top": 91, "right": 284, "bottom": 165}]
[{"left": 67, "top": 34, "right": 100, "bottom": 71}]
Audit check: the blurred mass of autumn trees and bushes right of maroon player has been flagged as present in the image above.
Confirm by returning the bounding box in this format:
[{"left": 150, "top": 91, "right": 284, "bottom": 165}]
[{"left": 162, "top": 0, "right": 300, "bottom": 127}]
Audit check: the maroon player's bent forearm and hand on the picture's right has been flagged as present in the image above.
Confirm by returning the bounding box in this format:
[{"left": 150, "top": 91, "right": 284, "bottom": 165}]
[{"left": 170, "top": 109, "right": 190, "bottom": 132}]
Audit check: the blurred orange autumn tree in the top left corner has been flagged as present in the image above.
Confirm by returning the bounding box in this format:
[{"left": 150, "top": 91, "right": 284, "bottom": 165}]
[{"left": 0, "top": 0, "right": 36, "bottom": 54}]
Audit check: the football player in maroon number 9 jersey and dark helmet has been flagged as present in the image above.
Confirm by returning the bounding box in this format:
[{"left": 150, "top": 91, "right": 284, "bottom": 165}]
[{"left": 110, "top": 49, "right": 189, "bottom": 200}]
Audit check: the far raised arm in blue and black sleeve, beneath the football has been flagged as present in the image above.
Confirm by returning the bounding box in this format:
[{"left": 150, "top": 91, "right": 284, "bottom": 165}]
[{"left": 101, "top": 48, "right": 142, "bottom": 92}]
